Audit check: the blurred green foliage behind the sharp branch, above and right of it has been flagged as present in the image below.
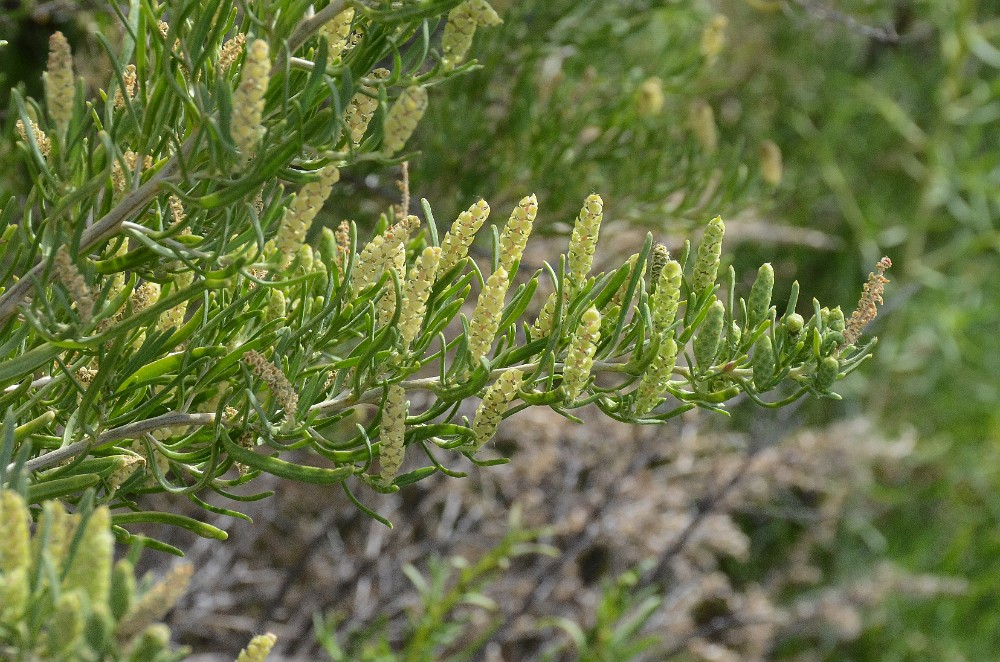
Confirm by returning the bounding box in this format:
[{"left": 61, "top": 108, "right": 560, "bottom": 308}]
[{"left": 0, "top": 0, "right": 1000, "bottom": 660}]
